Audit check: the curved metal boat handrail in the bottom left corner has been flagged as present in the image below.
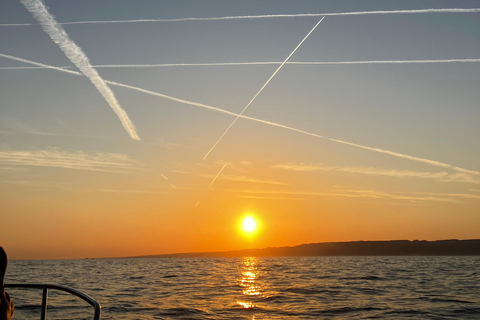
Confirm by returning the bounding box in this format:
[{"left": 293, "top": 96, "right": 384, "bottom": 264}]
[{"left": 5, "top": 283, "right": 101, "bottom": 320}]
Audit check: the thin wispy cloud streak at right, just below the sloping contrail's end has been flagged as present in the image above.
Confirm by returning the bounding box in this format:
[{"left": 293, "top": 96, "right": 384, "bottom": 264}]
[{"left": 272, "top": 163, "right": 480, "bottom": 184}]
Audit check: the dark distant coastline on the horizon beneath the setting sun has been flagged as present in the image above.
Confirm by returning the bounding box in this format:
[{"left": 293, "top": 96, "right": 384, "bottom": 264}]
[{"left": 130, "top": 239, "right": 480, "bottom": 258}]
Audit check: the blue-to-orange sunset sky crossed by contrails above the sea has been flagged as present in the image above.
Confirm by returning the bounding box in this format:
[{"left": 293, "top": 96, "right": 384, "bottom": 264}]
[{"left": 0, "top": 0, "right": 480, "bottom": 259}]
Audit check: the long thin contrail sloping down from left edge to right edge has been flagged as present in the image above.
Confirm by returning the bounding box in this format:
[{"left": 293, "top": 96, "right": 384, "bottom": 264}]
[{"left": 0, "top": 53, "right": 480, "bottom": 174}]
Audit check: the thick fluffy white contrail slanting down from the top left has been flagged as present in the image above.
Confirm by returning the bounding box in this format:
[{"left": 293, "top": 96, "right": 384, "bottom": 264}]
[{"left": 20, "top": 0, "right": 140, "bottom": 140}]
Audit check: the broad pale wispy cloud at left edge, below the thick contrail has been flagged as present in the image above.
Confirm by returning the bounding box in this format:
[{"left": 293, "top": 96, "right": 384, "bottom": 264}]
[{"left": 0, "top": 148, "right": 142, "bottom": 173}]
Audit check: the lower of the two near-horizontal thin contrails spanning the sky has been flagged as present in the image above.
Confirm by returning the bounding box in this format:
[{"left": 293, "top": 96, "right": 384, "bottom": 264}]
[{"left": 0, "top": 59, "right": 480, "bottom": 70}]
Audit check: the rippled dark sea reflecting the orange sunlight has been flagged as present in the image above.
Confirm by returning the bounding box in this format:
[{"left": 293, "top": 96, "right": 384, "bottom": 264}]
[{"left": 6, "top": 257, "right": 480, "bottom": 320}]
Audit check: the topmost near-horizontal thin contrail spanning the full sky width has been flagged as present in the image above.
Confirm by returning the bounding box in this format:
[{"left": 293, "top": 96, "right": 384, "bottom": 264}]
[{"left": 0, "top": 8, "right": 480, "bottom": 27}]
